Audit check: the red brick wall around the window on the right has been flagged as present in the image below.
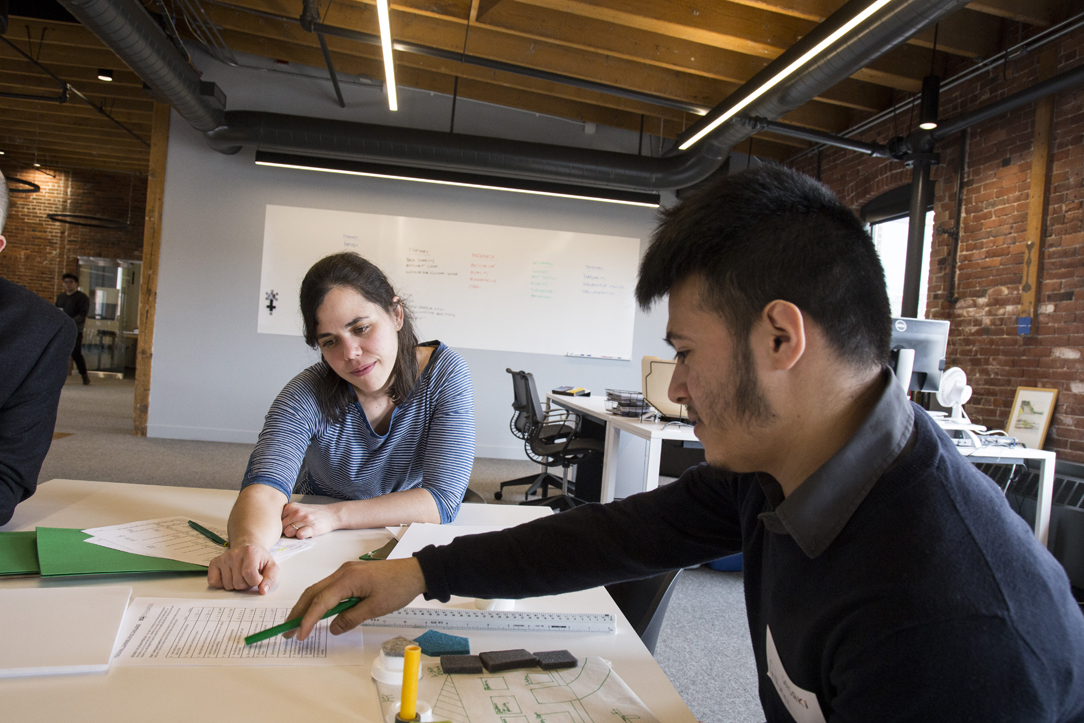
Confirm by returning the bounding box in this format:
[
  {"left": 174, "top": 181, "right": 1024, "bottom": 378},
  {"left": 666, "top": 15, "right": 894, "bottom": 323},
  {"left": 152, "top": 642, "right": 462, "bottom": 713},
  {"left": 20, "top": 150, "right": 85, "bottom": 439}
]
[{"left": 795, "top": 30, "right": 1084, "bottom": 462}]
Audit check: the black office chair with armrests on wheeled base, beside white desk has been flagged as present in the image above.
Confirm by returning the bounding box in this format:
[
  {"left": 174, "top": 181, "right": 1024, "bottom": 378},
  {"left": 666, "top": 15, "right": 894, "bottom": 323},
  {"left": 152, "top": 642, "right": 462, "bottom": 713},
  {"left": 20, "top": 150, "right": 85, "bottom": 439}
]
[{"left": 493, "top": 369, "right": 603, "bottom": 509}]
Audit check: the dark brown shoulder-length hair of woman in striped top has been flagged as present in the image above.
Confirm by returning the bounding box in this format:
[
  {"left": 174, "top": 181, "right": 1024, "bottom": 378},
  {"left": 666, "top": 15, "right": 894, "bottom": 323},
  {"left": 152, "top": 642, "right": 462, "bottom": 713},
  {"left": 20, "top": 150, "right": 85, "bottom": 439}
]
[{"left": 300, "top": 251, "right": 418, "bottom": 422}]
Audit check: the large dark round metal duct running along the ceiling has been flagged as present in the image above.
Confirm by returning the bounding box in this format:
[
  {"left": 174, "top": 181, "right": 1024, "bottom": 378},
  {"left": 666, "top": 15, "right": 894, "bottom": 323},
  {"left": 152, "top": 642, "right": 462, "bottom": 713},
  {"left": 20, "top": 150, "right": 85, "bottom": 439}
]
[{"left": 60, "top": 0, "right": 968, "bottom": 191}]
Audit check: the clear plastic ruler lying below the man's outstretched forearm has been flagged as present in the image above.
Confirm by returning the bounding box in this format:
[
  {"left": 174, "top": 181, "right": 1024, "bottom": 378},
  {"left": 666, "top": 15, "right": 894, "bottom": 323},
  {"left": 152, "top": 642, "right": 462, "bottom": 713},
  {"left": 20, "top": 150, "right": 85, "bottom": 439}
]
[{"left": 362, "top": 607, "right": 617, "bottom": 633}]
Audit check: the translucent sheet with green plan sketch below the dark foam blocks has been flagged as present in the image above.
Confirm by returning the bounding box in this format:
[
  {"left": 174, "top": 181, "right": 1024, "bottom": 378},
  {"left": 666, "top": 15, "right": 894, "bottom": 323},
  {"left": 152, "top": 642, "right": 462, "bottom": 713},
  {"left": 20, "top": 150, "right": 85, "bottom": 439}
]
[{"left": 376, "top": 657, "right": 658, "bottom": 723}]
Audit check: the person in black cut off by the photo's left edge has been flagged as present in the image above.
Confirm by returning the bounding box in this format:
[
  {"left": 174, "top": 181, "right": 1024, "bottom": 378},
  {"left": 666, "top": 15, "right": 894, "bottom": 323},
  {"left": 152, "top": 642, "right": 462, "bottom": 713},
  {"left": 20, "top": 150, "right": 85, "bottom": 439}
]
[{"left": 0, "top": 173, "right": 76, "bottom": 525}]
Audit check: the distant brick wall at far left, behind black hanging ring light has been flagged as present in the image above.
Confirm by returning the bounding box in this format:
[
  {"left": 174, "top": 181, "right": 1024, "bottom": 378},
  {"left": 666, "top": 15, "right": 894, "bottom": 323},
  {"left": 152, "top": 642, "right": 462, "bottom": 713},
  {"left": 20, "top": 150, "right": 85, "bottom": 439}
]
[{"left": 0, "top": 163, "right": 146, "bottom": 301}]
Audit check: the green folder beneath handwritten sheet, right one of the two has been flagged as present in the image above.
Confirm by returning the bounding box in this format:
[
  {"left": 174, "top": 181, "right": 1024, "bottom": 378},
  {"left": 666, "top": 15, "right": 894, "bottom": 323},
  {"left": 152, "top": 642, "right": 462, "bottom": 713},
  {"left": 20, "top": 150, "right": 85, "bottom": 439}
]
[{"left": 37, "top": 527, "right": 207, "bottom": 578}]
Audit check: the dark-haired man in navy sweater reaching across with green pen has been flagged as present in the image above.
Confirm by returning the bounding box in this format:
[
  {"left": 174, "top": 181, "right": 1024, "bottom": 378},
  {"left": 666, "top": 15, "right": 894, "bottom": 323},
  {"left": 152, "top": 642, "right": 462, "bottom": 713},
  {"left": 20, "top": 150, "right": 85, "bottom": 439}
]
[{"left": 281, "top": 168, "right": 1084, "bottom": 723}]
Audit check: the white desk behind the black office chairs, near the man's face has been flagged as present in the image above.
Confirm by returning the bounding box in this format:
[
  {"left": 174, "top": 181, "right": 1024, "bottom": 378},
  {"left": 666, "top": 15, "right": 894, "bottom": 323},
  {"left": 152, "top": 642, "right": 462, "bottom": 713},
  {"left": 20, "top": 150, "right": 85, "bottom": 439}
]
[{"left": 545, "top": 392, "right": 699, "bottom": 502}]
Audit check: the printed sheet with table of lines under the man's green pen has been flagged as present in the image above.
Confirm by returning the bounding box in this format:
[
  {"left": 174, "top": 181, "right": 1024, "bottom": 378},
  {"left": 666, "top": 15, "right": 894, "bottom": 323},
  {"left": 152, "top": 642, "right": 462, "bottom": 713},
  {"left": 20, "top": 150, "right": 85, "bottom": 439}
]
[{"left": 113, "top": 597, "right": 364, "bottom": 667}]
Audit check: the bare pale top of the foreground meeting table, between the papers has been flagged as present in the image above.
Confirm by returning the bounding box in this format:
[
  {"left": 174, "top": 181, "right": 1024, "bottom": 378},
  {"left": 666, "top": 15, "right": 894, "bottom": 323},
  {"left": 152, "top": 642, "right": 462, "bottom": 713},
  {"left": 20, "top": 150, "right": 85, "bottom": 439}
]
[{"left": 0, "top": 480, "right": 696, "bottom": 723}]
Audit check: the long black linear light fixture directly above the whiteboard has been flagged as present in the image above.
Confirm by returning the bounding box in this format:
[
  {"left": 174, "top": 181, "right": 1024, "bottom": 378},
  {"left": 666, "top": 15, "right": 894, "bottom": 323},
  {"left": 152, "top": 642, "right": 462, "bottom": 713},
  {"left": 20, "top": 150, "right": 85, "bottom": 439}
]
[{"left": 256, "top": 151, "right": 659, "bottom": 208}]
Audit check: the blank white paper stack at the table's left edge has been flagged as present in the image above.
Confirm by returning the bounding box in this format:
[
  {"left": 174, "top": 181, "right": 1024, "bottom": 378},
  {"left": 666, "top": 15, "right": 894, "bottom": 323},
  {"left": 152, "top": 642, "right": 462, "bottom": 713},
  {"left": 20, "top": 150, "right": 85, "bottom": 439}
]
[{"left": 0, "top": 585, "right": 132, "bottom": 677}]
